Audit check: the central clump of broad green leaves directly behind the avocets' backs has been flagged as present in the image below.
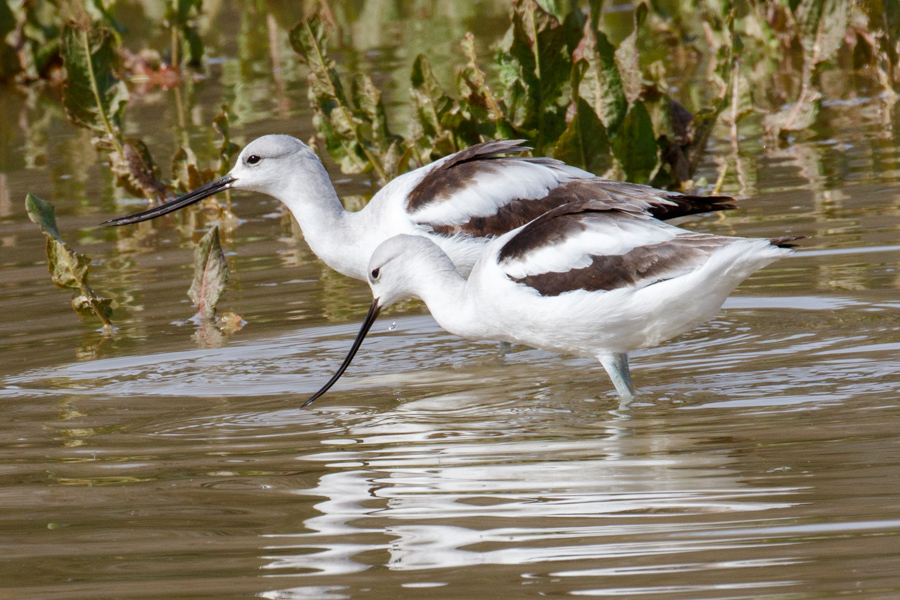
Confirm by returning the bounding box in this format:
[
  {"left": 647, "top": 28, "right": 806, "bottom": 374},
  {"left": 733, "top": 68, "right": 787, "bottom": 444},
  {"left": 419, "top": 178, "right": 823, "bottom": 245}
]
[{"left": 291, "top": 0, "right": 733, "bottom": 186}]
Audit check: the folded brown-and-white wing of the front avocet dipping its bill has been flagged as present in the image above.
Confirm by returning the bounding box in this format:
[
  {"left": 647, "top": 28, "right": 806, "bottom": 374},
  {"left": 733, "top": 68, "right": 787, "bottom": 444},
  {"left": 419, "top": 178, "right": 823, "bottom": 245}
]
[{"left": 496, "top": 201, "right": 797, "bottom": 296}]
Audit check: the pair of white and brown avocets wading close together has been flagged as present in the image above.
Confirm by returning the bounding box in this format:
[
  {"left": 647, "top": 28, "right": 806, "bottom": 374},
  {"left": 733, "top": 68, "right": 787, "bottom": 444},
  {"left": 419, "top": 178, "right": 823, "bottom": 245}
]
[{"left": 105, "top": 135, "right": 802, "bottom": 406}]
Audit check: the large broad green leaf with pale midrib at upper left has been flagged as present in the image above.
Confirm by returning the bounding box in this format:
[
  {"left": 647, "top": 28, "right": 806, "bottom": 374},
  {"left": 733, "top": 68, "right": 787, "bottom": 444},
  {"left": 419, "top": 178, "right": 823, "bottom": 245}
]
[{"left": 62, "top": 25, "right": 128, "bottom": 143}]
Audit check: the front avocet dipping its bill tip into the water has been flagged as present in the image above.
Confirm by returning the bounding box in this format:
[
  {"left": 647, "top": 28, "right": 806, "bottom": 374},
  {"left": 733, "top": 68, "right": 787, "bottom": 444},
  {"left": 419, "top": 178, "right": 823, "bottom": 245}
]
[{"left": 304, "top": 200, "right": 802, "bottom": 406}]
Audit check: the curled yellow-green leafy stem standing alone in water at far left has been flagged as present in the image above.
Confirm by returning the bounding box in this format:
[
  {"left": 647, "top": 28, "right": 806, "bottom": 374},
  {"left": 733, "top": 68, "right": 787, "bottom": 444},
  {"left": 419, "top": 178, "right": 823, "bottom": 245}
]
[{"left": 25, "top": 194, "right": 112, "bottom": 335}]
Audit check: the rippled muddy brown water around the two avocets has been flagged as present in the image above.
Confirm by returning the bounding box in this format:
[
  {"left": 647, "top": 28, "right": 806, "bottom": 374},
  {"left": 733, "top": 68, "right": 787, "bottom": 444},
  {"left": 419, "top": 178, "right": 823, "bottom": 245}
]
[{"left": 0, "top": 4, "right": 900, "bottom": 600}]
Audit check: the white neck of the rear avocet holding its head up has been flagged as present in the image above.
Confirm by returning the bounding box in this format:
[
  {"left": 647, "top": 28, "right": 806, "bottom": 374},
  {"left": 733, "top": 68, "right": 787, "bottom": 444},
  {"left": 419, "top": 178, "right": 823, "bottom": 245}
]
[{"left": 269, "top": 162, "right": 377, "bottom": 280}]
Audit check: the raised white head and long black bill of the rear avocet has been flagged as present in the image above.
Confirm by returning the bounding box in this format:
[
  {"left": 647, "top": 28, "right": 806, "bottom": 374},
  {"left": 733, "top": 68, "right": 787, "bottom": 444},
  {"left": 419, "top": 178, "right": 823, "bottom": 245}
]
[{"left": 103, "top": 135, "right": 322, "bottom": 225}]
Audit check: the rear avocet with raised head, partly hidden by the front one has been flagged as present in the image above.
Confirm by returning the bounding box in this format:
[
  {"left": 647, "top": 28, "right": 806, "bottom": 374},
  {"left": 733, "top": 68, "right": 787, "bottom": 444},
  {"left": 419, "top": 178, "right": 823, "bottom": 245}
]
[{"left": 104, "top": 135, "right": 734, "bottom": 280}]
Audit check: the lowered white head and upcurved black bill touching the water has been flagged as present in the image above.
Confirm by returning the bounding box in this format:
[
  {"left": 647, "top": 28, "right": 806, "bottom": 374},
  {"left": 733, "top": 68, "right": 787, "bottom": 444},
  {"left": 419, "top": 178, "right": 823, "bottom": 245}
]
[{"left": 303, "top": 235, "right": 442, "bottom": 406}]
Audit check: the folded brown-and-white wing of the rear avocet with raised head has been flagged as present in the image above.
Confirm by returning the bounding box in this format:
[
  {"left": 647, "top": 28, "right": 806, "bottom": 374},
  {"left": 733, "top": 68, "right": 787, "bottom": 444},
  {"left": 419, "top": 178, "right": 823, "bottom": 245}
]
[{"left": 406, "top": 141, "right": 734, "bottom": 237}]
